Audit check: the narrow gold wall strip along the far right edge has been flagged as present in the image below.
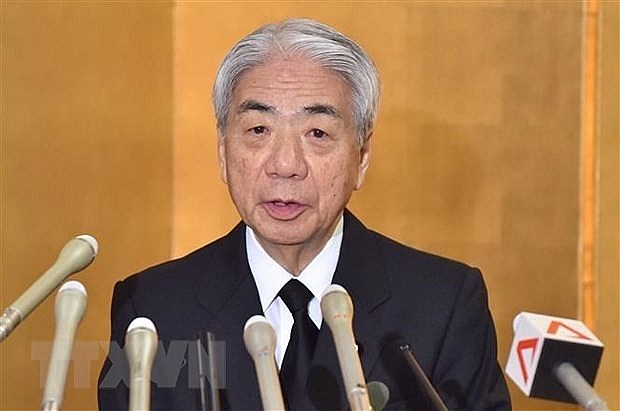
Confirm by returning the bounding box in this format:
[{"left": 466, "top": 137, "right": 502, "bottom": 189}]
[{"left": 596, "top": 2, "right": 620, "bottom": 410}]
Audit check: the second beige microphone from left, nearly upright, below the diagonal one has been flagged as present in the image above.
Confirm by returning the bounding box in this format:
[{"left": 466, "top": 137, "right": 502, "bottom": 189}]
[{"left": 41, "top": 281, "right": 87, "bottom": 411}]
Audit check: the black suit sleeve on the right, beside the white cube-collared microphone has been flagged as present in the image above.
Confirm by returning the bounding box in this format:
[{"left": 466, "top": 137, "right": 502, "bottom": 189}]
[{"left": 432, "top": 269, "right": 511, "bottom": 410}]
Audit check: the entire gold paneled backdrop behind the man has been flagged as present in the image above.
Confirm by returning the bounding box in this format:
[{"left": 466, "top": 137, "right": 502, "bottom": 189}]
[{"left": 0, "top": 0, "right": 620, "bottom": 410}]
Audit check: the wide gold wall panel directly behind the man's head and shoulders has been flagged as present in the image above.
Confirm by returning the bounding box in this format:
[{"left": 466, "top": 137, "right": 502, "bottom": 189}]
[{"left": 173, "top": 2, "right": 592, "bottom": 409}]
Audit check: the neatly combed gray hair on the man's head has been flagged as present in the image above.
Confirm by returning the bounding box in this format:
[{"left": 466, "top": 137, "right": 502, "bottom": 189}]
[{"left": 213, "top": 19, "right": 380, "bottom": 145}]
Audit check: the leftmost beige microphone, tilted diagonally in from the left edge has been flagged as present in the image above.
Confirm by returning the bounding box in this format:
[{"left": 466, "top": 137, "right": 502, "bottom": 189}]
[{"left": 0, "top": 234, "right": 99, "bottom": 342}]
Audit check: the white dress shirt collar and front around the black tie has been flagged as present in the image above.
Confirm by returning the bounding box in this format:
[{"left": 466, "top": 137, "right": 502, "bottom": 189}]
[{"left": 245, "top": 216, "right": 344, "bottom": 368}]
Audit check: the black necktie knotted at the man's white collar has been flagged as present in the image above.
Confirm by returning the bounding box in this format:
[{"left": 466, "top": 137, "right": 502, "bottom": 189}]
[{"left": 278, "top": 279, "right": 319, "bottom": 410}]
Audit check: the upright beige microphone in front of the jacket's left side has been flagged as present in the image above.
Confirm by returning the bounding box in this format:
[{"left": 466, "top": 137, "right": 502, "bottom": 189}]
[{"left": 125, "top": 317, "right": 157, "bottom": 411}]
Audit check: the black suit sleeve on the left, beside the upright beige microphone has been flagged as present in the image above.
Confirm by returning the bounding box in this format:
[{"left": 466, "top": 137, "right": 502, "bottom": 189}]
[{"left": 97, "top": 281, "right": 136, "bottom": 411}]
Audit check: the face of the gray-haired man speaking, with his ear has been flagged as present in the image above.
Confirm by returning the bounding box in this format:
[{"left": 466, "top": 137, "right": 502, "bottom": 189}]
[{"left": 218, "top": 54, "right": 370, "bottom": 252}]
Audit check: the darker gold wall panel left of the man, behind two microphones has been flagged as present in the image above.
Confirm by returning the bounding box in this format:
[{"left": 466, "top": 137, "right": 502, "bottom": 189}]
[{"left": 0, "top": 1, "right": 172, "bottom": 410}]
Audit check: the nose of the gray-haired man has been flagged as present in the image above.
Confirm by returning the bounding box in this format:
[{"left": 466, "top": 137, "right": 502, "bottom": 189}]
[{"left": 266, "top": 133, "right": 308, "bottom": 179}]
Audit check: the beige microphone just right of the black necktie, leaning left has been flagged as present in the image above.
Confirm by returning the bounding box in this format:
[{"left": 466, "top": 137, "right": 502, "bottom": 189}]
[{"left": 321, "top": 284, "right": 370, "bottom": 411}]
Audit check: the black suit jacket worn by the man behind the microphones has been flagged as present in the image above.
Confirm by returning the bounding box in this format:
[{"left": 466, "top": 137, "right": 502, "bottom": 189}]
[{"left": 99, "top": 210, "right": 510, "bottom": 410}]
